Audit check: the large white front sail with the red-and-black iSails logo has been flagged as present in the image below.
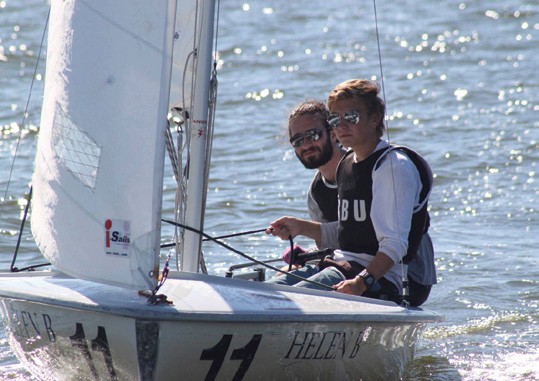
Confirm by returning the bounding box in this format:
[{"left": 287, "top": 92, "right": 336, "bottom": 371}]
[{"left": 32, "top": 0, "right": 176, "bottom": 288}]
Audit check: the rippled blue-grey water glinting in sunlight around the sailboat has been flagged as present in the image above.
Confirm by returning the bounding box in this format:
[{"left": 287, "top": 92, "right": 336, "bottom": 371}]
[{"left": 0, "top": 0, "right": 539, "bottom": 380}]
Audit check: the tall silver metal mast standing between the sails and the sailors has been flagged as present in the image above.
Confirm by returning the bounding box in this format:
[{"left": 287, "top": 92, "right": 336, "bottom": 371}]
[{"left": 182, "top": 0, "right": 215, "bottom": 272}]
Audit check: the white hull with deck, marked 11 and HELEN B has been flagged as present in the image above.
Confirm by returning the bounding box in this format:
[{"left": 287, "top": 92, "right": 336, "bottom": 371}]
[{"left": 0, "top": 272, "right": 439, "bottom": 381}]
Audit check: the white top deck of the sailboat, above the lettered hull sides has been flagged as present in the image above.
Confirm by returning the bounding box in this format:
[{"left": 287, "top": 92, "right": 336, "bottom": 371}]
[{"left": 0, "top": 272, "right": 439, "bottom": 323}]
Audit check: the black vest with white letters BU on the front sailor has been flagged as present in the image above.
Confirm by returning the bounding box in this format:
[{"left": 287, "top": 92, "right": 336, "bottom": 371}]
[{"left": 337, "top": 146, "right": 433, "bottom": 263}]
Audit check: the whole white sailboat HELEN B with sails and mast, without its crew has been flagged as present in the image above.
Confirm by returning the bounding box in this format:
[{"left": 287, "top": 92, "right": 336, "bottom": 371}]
[{"left": 0, "top": 0, "right": 440, "bottom": 380}]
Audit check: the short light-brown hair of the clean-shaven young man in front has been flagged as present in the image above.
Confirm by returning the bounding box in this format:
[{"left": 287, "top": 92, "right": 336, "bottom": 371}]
[{"left": 327, "top": 79, "right": 386, "bottom": 136}]
